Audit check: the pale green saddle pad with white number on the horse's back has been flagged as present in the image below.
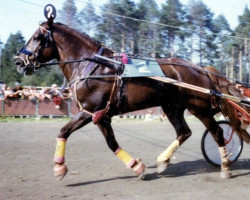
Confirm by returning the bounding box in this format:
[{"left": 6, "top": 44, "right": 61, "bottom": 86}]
[{"left": 122, "top": 58, "right": 165, "bottom": 78}]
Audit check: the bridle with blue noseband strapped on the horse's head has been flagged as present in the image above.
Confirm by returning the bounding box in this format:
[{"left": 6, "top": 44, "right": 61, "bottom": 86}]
[{"left": 14, "top": 25, "right": 54, "bottom": 71}]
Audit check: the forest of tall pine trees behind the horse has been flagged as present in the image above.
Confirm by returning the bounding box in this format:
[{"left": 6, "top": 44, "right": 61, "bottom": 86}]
[{"left": 0, "top": 0, "right": 250, "bottom": 86}]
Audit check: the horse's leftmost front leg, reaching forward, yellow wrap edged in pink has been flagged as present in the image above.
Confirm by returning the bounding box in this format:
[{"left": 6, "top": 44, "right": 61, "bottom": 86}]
[{"left": 54, "top": 112, "right": 92, "bottom": 179}]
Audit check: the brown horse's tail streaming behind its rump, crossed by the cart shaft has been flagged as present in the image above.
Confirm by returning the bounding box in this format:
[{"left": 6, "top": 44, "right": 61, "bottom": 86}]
[{"left": 205, "top": 67, "right": 250, "bottom": 143}]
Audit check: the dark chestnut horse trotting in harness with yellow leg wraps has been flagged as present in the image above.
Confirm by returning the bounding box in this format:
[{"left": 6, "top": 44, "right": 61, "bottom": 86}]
[{"left": 15, "top": 20, "right": 250, "bottom": 178}]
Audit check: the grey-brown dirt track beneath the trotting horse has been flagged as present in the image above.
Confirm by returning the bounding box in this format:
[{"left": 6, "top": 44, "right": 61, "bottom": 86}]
[{"left": 0, "top": 121, "right": 250, "bottom": 200}]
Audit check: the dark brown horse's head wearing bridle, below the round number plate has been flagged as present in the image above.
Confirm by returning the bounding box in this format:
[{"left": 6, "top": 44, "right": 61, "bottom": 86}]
[{"left": 14, "top": 22, "right": 58, "bottom": 75}]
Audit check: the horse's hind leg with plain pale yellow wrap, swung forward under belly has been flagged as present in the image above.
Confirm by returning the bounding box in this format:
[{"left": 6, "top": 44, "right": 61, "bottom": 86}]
[{"left": 157, "top": 105, "right": 192, "bottom": 173}]
